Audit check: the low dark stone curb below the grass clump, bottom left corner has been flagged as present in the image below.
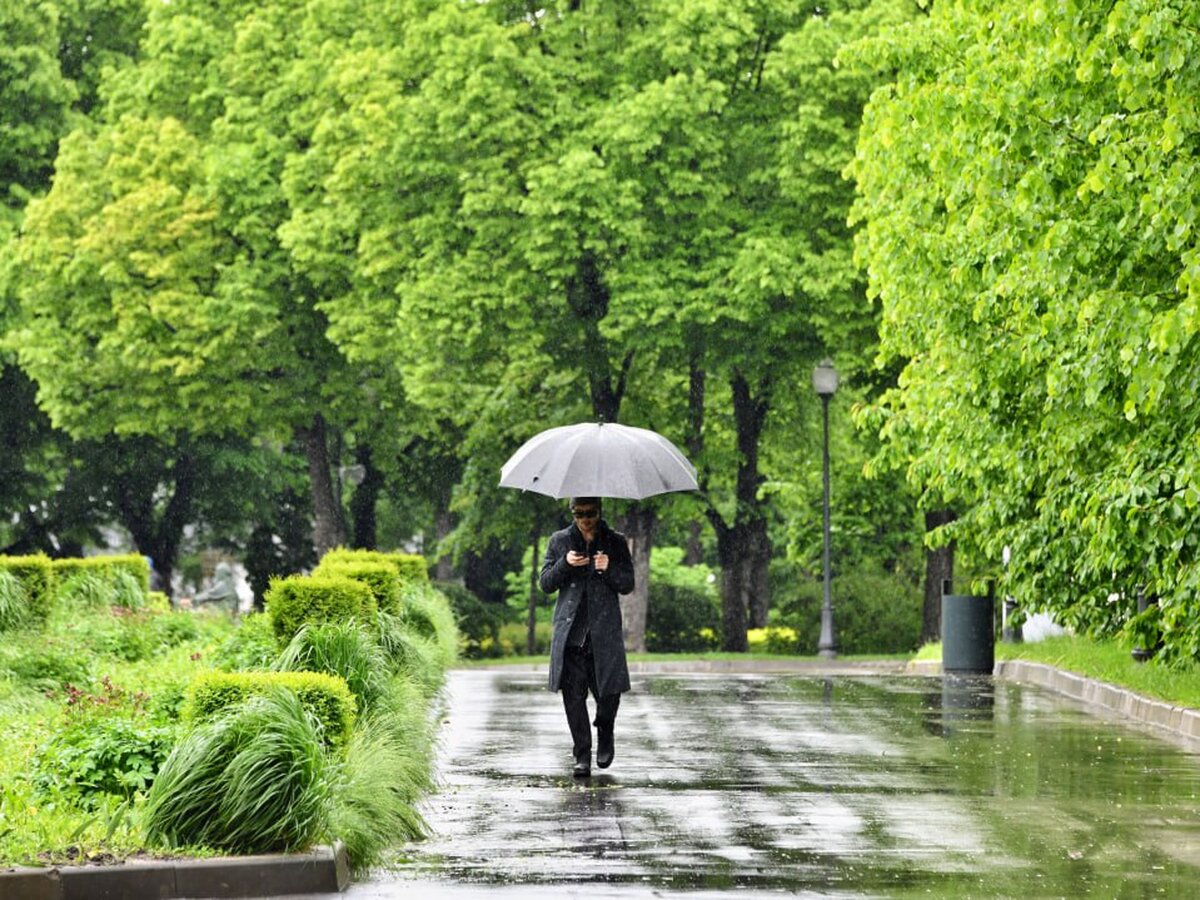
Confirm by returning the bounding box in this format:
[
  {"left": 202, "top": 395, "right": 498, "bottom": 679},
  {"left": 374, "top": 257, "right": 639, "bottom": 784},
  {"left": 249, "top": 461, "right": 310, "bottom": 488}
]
[{"left": 0, "top": 842, "right": 350, "bottom": 900}]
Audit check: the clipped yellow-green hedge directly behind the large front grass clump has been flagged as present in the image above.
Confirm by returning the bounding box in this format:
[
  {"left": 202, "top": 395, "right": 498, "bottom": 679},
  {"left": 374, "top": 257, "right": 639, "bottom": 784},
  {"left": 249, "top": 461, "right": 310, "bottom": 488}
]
[{"left": 184, "top": 671, "right": 358, "bottom": 746}]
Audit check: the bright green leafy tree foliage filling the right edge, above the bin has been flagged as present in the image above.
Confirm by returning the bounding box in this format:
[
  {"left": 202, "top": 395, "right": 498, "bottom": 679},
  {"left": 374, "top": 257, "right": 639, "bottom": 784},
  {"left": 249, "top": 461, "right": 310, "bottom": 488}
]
[{"left": 850, "top": 0, "right": 1200, "bottom": 662}]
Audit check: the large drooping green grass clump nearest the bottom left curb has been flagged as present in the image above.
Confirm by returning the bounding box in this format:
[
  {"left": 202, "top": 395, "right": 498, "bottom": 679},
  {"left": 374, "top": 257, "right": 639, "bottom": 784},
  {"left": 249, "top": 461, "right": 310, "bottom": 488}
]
[{"left": 145, "top": 686, "right": 333, "bottom": 853}]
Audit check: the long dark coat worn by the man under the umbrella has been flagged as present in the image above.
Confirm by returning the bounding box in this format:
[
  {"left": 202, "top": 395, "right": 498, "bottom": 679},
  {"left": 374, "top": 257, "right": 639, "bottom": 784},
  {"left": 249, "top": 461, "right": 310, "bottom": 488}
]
[{"left": 541, "top": 520, "right": 634, "bottom": 696}]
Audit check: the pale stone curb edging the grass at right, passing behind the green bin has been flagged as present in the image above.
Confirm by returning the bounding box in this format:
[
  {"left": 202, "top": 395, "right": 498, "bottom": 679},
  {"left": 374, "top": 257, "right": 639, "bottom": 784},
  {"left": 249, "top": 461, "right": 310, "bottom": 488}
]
[{"left": 906, "top": 659, "right": 1200, "bottom": 740}]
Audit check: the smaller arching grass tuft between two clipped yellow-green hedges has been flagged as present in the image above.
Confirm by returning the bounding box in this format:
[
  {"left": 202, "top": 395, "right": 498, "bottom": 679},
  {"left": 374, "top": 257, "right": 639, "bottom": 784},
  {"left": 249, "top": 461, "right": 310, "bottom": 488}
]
[{"left": 272, "top": 622, "right": 391, "bottom": 712}]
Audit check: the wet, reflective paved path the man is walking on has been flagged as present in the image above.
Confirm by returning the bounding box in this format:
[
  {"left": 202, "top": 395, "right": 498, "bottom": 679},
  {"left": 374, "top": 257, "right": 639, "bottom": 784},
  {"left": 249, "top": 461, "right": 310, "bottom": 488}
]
[{"left": 324, "top": 668, "right": 1200, "bottom": 900}]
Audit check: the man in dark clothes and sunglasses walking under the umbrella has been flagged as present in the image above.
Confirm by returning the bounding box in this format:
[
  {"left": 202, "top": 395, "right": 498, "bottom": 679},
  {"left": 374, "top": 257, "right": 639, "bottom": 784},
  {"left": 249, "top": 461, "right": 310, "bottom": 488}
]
[{"left": 541, "top": 497, "right": 634, "bottom": 778}]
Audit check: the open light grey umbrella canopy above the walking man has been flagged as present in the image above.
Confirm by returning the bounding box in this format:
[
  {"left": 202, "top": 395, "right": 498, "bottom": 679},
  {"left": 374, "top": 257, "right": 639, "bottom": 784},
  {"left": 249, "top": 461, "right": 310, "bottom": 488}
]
[{"left": 500, "top": 422, "right": 697, "bottom": 500}]
